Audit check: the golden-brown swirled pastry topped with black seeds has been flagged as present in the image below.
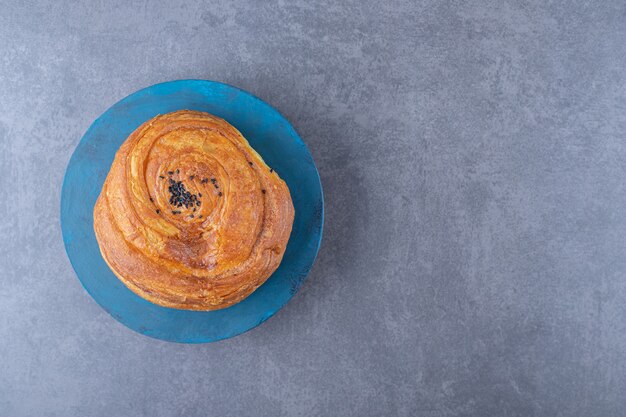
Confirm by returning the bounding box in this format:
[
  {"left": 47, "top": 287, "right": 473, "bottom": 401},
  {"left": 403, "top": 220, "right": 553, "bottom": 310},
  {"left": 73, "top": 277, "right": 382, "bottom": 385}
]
[{"left": 94, "top": 110, "right": 294, "bottom": 310}]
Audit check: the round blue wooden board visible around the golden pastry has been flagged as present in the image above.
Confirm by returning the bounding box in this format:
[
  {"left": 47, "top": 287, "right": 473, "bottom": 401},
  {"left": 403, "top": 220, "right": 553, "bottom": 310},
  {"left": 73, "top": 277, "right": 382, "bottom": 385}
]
[{"left": 61, "top": 80, "right": 324, "bottom": 343}]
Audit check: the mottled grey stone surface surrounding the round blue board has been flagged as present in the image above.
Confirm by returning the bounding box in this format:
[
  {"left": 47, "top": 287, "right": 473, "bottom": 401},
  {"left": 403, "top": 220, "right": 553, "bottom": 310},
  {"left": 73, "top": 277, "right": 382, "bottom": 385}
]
[{"left": 0, "top": 0, "right": 626, "bottom": 417}]
